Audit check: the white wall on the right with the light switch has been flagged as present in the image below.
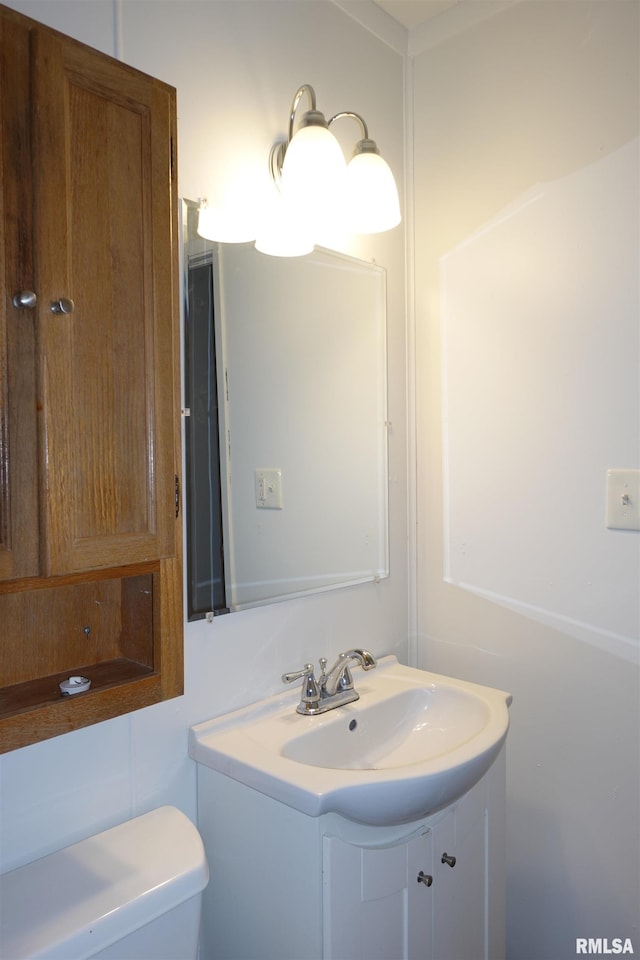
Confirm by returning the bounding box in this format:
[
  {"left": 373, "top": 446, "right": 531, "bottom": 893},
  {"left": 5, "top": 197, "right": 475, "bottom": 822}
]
[{"left": 411, "top": 0, "right": 640, "bottom": 960}]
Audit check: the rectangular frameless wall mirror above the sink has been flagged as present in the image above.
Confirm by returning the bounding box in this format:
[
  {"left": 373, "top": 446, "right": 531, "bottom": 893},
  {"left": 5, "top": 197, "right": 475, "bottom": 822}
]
[{"left": 182, "top": 200, "right": 389, "bottom": 620}]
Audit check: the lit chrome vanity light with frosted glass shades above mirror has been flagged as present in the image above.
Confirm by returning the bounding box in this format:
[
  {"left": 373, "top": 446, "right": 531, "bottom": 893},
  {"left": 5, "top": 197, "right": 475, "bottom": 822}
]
[{"left": 256, "top": 83, "right": 401, "bottom": 256}]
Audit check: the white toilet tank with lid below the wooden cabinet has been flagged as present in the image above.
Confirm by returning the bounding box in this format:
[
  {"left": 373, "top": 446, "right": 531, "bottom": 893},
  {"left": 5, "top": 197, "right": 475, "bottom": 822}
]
[{"left": 0, "top": 807, "right": 209, "bottom": 960}]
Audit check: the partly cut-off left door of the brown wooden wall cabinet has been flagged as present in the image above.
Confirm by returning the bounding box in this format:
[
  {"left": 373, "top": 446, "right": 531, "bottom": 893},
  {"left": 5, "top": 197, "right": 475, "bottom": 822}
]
[{"left": 0, "top": 13, "right": 39, "bottom": 580}]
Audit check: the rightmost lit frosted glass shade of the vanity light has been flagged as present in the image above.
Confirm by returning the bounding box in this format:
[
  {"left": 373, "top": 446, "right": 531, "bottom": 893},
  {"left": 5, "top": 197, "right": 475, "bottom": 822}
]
[{"left": 345, "top": 152, "right": 401, "bottom": 233}]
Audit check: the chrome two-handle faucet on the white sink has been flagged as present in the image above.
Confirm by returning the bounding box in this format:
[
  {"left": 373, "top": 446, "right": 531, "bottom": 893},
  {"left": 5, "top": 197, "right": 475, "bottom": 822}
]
[{"left": 282, "top": 650, "right": 376, "bottom": 716}]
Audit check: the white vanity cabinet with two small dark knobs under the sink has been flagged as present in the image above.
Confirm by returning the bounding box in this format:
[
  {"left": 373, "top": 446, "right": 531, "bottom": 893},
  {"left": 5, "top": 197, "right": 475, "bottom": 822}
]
[{"left": 198, "top": 748, "right": 505, "bottom": 960}]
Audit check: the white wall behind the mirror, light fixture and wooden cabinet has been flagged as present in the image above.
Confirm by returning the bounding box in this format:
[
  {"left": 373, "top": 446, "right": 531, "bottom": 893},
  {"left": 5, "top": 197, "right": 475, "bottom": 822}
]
[{"left": 0, "top": 0, "right": 407, "bottom": 871}]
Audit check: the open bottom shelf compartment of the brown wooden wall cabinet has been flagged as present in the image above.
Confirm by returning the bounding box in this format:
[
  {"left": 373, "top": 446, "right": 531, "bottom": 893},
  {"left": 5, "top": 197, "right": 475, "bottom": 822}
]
[{"left": 0, "top": 561, "right": 180, "bottom": 752}]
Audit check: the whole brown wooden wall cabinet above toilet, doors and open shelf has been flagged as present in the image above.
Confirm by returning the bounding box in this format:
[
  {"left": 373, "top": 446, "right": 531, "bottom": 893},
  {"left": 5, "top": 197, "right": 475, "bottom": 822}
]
[{"left": 0, "top": 6, "right": 183, "bottom": 751}]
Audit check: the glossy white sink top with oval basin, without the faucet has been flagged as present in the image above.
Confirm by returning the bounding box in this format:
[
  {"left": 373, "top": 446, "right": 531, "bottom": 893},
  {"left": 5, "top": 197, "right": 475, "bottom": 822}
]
[{"left": 189, "top": 657, "right": 511, "bottom": 825}]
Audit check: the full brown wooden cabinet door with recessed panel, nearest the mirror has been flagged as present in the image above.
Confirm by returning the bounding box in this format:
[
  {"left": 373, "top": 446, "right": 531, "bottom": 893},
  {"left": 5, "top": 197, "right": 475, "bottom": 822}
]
[{"left": 31, "top": 29, "right": 179, "bottom": 576}]
